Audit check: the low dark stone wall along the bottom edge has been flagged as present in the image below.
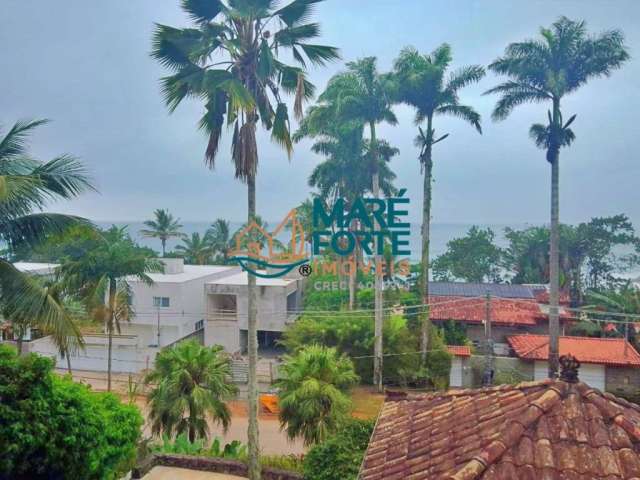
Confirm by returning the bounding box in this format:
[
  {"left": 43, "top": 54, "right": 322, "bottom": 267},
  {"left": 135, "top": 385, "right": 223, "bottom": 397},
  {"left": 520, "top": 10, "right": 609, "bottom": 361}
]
[{"left": 132, "top": 454, "right": 303, "bottom": 480}]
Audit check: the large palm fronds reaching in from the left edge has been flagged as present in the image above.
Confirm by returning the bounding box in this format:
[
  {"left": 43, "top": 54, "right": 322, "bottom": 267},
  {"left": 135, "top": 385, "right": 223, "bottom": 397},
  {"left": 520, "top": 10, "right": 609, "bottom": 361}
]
[{"left": 0, "top": 120, "right": 94, "bottom": 354}]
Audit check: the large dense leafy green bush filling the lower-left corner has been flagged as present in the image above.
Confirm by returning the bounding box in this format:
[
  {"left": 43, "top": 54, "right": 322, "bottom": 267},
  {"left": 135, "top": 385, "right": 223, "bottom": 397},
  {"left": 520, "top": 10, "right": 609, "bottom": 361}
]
[{"left": 0, "top": 345, "right": 142, "bottom": 480}]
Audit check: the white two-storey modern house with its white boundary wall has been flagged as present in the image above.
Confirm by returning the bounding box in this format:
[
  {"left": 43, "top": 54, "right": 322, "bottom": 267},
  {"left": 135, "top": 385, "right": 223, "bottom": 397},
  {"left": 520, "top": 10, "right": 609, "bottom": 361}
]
[{"left": 6, "top": 258, "right": 302, "bottom": 373}]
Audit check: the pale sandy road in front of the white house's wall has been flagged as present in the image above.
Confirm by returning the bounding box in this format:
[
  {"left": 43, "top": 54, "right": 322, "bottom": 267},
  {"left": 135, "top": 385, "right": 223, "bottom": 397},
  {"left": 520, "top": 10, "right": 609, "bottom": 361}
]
[{"left": 58, "top": 370, "right": 305, "bottom": 456}]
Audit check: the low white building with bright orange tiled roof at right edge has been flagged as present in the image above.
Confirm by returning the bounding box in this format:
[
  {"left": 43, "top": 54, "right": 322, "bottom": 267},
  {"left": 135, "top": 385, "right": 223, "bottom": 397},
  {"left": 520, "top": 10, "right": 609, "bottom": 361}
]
[{"left": 508, "top": 335, "right": 640, "bottom": 395}]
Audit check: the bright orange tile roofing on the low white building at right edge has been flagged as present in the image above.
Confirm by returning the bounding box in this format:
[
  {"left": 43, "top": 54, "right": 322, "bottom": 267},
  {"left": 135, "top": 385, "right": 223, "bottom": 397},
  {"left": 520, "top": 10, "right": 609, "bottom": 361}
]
[{"left": 507, "top": 335, "right": 640, "bottom": 366}]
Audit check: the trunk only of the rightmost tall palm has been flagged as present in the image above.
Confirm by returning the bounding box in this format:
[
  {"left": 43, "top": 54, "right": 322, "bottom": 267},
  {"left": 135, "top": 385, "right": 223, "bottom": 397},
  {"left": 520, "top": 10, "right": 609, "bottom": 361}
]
[{"left": 549, "top": 99, "right": 561, "bottom": 378}]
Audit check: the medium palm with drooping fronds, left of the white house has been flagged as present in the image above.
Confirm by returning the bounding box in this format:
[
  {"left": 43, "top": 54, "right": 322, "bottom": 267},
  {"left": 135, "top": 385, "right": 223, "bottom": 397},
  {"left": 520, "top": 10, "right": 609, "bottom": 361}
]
[{"left": 60, "top": 226, "right": 162, "bottom": 391}]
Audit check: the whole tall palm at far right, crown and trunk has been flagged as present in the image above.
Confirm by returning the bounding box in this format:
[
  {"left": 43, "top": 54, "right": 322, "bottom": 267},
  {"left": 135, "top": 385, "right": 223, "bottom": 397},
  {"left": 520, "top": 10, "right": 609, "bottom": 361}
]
[{"left": 486, "top": 17, "right": 629, "bottom": 377}]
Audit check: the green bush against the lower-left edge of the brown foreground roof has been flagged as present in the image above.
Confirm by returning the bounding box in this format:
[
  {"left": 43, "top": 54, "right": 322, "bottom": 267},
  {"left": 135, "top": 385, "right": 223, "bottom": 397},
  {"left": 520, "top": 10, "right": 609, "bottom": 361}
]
[{"left": 304, "top": 419, "right": 374, "bottom": 480}]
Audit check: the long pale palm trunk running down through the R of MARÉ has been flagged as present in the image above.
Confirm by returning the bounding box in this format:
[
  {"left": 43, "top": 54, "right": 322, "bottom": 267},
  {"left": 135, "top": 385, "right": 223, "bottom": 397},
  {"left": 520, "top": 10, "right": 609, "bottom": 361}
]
[{"left": 369, "top": 122, "right": 384, "bottom": 392}]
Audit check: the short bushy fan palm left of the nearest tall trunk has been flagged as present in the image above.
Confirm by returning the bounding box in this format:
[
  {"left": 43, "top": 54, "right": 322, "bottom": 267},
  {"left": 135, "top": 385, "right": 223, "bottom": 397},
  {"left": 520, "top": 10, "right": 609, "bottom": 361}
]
[{"left": 145, "top": 340, "right": 237, "bottom": 443}]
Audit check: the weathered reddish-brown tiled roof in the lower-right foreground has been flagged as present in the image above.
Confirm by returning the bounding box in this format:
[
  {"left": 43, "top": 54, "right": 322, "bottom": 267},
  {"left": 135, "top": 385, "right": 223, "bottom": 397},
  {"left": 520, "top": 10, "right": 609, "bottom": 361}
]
[{"left": 359, "top": 380, "right": 640, "bottom": 480}]
